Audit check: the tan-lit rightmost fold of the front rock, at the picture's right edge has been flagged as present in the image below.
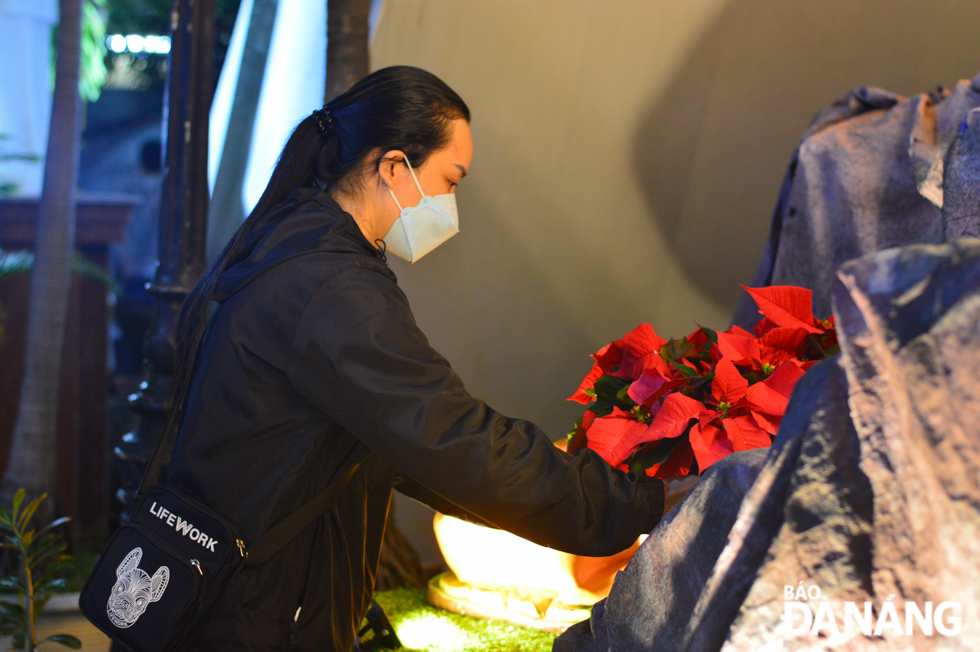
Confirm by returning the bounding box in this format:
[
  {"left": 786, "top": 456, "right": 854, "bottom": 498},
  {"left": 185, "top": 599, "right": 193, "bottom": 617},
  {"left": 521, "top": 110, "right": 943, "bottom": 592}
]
[{"left": 835, "top": 240, "right": 980, "bottom": 650}]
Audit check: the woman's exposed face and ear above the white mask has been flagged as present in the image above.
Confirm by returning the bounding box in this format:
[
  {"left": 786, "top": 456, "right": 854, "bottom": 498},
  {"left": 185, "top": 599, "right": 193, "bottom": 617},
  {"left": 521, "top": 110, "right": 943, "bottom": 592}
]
[{"left": 379, "top": 118, "right": 473, "bottom": 216}]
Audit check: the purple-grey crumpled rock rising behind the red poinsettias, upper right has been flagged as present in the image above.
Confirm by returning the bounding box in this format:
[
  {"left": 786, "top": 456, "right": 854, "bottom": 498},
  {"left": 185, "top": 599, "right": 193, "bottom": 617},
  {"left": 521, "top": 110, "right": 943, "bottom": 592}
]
[{"left": 733, "top": 75, "right": 980, "bottom": 328}]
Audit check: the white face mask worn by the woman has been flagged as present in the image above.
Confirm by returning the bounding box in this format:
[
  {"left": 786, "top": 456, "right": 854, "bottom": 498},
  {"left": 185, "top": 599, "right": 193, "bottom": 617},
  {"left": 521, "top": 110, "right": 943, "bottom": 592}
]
[{"left": 384, "top": 156, "right": 459, "bottom": 263}]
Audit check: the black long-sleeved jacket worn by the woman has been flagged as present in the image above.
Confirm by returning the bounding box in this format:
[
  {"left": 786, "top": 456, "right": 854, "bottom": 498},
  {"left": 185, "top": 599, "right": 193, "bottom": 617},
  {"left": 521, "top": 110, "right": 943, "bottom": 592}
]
[{"left": 168, "top": 188, "right": 664, "bottom": 652}]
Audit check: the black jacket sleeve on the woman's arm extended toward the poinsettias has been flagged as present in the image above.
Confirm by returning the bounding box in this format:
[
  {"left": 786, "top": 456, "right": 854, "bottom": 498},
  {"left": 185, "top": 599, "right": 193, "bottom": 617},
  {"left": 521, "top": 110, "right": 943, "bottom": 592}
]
[{"left": 287, "top": 267, "right": 664, "bottom": 556}]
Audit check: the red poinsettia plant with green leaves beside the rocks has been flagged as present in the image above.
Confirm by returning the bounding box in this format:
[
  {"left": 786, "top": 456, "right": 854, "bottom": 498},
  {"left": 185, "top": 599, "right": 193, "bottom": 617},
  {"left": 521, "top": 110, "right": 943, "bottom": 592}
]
[{"left": 568, "top": 285, "right": 839, "bottom": 478}]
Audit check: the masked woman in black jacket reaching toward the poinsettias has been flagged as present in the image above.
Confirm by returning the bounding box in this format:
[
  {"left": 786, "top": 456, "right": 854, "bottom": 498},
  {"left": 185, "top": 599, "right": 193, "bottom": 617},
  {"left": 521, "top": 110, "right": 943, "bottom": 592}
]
[{"left": 168, "top": 67, "right": 684, "bottom": 651}]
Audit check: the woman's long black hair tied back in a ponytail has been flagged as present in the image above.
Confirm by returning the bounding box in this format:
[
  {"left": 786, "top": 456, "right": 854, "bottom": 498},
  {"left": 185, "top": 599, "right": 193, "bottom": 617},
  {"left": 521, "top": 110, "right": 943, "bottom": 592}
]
[{"left": 171, "top": 66, "right": 470, "bottom": 413}]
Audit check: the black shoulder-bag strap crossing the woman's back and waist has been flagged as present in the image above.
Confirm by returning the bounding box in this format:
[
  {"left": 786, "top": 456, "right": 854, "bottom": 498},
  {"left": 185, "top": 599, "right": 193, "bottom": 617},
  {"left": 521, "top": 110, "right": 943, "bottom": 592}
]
[{"left": 136, "top": 302, "right": 370, "bottom": 566}]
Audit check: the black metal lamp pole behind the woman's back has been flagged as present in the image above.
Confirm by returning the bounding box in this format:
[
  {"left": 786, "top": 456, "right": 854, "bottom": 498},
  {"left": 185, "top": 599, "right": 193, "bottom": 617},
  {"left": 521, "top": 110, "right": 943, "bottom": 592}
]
[{"left": 114, "top": 0, "right": 215, "bottom": 518}]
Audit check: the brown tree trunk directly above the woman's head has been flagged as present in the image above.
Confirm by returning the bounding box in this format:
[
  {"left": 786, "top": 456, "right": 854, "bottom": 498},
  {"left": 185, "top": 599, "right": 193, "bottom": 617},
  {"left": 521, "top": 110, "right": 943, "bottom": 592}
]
[{"left": 323, "top": 0, "right": 371, "bottom": 104}]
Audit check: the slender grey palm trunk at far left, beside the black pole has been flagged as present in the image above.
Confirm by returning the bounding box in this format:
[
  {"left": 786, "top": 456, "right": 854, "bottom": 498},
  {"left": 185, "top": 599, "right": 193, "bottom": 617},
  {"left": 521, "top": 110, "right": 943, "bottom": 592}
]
[{"left": 0, "top": 0, "right": 84, "bottom": 520}]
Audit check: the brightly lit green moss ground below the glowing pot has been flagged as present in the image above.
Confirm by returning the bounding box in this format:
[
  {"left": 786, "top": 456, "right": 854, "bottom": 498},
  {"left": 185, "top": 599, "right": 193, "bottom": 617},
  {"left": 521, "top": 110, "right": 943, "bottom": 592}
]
[{"left": 374, "top": 589, "right": 555, "bottom": 652}]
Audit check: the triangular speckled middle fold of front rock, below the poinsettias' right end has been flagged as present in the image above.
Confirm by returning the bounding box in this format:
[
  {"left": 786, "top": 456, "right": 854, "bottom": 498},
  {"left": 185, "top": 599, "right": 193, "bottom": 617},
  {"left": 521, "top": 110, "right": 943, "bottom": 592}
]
[{"left": 684, "top": 359, "right": 872, "bottom": 650}]
